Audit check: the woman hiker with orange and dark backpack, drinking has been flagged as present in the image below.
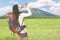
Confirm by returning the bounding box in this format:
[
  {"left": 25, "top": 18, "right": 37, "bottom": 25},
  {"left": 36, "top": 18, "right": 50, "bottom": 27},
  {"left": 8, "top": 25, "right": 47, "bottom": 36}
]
[{"left": 7, "top": 4, "right": 32, "bottom": 40}]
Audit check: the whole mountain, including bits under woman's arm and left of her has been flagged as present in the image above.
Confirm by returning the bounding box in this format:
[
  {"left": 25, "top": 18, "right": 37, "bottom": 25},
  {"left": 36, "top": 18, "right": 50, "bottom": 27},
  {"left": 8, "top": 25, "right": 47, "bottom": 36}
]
[{"left": 2, "top": 8, "right": 60, "bottom": 18}]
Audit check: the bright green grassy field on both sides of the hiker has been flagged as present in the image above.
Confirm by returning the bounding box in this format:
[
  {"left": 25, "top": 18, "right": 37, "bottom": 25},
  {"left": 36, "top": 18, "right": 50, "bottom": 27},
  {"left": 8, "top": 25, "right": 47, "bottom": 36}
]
[{"left": 0, "top": 19, "right": 60, "bottom": 40}]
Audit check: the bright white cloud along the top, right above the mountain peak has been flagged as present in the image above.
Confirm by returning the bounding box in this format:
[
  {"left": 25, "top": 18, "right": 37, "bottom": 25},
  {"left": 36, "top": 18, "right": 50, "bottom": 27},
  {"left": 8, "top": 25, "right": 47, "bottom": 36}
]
[{"left": 28, "top": 0, "right": 55, "bottom": 8}]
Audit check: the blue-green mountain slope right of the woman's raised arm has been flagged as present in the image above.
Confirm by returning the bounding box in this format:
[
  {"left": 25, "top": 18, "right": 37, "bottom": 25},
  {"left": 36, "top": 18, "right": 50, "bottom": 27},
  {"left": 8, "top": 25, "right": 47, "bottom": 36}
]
[{"left": 31, "top": 8, "right": 59, "bottom": 18}]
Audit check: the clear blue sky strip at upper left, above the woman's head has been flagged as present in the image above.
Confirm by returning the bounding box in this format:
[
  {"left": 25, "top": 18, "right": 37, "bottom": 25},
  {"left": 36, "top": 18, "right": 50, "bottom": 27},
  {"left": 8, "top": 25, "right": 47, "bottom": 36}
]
[{"left": 0, "top": 0, "right": 36, "bottom": 7}]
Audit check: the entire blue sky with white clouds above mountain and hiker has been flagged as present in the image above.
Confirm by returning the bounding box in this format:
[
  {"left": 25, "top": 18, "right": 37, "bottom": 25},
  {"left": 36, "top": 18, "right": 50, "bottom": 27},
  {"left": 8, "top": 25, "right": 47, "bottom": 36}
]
[{"left": 0, "top": 0, "right": 60, "bottom": 16}]
